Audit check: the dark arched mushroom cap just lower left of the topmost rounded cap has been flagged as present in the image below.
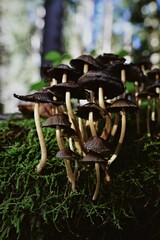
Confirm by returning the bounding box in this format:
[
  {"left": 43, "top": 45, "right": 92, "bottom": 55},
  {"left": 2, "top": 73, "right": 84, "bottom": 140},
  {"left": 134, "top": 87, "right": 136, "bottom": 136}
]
[{"left": 48, "top": 64, "right": 80, "bottom": 82}]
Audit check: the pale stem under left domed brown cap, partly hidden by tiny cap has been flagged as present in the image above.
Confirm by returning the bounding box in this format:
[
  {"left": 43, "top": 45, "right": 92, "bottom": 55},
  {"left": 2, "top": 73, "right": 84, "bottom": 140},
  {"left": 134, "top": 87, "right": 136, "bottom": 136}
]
[{"left": 56, "top": 126, "right": 76, "bottom": 191}]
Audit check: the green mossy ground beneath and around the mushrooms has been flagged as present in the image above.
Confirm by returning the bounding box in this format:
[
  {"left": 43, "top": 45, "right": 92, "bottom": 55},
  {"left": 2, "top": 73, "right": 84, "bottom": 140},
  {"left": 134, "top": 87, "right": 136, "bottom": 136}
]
[{"left": 0, "top": 115, "right": 160, "bottom": 240}]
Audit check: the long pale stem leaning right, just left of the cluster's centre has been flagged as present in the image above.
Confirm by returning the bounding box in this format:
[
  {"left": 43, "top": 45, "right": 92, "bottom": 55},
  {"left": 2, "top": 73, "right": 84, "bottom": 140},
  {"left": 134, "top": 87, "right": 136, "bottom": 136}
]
[{"left": 66, "top": 91, "right": 84, "bottom": 153}]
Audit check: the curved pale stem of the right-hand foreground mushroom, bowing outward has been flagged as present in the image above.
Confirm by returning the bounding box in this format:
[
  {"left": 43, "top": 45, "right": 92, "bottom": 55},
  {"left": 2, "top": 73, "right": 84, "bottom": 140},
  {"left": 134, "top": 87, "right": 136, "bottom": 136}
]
[{"left": 108, "top": 109, "right": 126, "bottom": 166}]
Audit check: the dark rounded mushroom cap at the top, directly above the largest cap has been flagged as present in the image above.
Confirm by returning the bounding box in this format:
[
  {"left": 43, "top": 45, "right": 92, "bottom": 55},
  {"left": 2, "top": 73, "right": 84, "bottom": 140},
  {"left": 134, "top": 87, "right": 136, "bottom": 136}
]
[{"left": 70, "top": 54, "right": 99, "bottom": 74}]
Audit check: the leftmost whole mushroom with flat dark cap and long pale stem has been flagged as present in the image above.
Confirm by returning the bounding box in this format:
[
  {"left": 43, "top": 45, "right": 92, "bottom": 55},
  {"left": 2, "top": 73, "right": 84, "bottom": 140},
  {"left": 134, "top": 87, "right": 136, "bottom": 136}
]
[{"left": 14, "top": 89, "right": 61, "bottom": 173}]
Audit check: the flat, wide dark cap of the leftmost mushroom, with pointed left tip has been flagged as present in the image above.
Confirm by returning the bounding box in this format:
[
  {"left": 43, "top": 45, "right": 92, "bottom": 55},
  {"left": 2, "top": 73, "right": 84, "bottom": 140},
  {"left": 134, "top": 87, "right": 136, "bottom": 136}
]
[{"left": 13, "top": 89, "right": 63, "bottom": 105}]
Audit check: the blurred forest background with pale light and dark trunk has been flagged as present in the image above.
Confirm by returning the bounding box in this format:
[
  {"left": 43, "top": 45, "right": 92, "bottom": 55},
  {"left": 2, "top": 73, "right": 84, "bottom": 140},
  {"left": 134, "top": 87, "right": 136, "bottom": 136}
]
[{"left": 0, "top": 0, "right": 160, "bottom": 113}]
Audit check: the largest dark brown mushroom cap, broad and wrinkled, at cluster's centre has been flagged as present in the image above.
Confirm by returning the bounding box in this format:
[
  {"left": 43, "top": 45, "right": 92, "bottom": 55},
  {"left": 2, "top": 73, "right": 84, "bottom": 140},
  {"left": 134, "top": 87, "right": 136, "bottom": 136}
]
[{"left": 78, "top": 70, "right": 125, "bottom": 99}]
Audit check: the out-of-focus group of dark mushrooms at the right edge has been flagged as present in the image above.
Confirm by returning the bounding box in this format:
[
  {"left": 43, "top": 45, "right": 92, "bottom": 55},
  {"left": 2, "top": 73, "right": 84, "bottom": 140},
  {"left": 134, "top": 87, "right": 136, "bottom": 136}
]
[{"left": 135, "top": 66, "right": 160, "bottom": 138}]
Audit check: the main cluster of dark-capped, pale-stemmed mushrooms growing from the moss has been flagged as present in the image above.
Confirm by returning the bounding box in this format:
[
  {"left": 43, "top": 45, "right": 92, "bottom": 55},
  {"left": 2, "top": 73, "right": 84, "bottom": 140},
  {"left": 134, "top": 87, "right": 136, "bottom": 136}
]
[{"left": 14, "top": 53, "right": 142, "bottom": 200}]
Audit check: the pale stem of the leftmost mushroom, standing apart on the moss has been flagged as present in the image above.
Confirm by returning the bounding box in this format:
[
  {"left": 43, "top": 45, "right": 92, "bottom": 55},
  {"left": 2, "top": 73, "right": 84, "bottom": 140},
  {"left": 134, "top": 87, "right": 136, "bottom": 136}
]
[{"left": 34, "top": 103, "right": 47, "bottom": 173}]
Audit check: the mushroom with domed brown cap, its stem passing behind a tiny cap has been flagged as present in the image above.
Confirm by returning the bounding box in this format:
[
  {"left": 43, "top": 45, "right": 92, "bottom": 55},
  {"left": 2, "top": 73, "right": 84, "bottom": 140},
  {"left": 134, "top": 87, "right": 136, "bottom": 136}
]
[{"left": 42, "top": 113, "right": 76, "bottom": 190}]
